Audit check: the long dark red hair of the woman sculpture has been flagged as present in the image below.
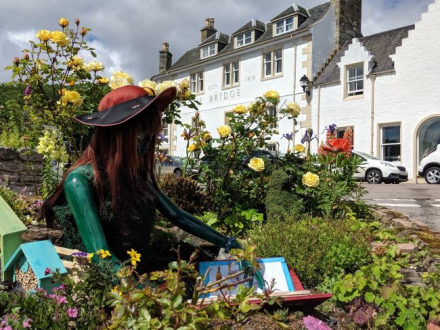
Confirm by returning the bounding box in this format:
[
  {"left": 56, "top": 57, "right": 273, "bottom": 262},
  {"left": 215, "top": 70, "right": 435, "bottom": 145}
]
[{"left": 40, "top": 106, "right": 162, "bottom": 227}]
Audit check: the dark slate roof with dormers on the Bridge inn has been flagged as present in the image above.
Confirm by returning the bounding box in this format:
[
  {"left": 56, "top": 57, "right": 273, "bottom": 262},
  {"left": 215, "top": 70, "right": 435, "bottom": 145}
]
[{"left": 158, "top": 2, "right": 330, "bottom": 75}]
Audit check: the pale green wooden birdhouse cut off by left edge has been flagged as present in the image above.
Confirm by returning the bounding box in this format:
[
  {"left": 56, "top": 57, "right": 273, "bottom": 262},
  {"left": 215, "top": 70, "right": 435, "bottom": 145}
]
[{"left": 0, "top": 196, "right": 26, "bottom": 281}]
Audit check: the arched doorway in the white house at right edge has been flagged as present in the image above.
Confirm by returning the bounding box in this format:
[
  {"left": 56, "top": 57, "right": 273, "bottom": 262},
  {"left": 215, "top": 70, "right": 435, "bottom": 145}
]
[{"left": 417, "top": 116, "right": 440, "bottom": 165}]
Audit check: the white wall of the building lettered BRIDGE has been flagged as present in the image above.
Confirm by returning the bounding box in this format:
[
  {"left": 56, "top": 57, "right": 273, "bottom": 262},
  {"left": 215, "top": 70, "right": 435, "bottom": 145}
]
[{"left": 167, "top": 37, "right": 307, "bottom": 156}]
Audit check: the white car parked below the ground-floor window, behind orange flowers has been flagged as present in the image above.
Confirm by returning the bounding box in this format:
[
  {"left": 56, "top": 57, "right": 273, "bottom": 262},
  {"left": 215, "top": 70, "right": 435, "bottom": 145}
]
[{"left": 353, "top": 151, "right": 408, "bottom": 184}]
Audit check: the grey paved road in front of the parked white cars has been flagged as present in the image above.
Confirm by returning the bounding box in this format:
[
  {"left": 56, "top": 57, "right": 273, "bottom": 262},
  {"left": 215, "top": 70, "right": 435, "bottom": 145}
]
[{"left": 363, "top": 183, "right": 440, "bottom": 231}]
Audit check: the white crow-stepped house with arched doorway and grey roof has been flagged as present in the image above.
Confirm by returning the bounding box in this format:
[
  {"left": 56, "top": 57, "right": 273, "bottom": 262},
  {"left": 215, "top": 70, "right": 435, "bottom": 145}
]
[{"left": 312, "top": 0, "right": 440, "bottom": 182}]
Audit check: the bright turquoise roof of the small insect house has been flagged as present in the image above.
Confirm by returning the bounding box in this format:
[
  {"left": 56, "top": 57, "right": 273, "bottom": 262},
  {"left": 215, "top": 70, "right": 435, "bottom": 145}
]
[{"left": 5, "top": 241, "right": 67, "bottom": 280}]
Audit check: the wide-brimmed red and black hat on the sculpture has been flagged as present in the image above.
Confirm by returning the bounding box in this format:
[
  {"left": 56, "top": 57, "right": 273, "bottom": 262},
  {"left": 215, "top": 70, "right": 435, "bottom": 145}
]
[{"left": 75, "top": 85, "right": 177, "bottom": 127}]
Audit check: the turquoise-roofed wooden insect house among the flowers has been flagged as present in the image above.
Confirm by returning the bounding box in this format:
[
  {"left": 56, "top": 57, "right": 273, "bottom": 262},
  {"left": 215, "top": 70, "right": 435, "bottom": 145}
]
[{"left": 5, "top": 241, "right": 67, "bottom": 292}]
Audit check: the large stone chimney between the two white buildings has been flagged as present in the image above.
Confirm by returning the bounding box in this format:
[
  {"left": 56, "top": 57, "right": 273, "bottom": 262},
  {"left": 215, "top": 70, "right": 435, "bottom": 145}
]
[{"left": 331, "top": 0, "right": 362, "bottom": 49}]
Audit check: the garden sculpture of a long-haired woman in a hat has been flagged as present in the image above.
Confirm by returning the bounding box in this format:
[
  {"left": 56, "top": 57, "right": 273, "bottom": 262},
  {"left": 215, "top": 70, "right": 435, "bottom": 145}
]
[{"left": 42, "top": 85, "right": 262, "bottom": 286}]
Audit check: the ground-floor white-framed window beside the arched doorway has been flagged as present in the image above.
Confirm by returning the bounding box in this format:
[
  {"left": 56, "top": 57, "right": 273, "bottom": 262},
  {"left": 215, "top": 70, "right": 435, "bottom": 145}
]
[{"left": 380, "top": 124, "right": 401, "bottom": 162}]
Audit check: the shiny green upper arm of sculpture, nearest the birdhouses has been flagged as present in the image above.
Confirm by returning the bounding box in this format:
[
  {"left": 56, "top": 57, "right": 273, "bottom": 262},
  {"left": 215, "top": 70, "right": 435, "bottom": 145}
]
[{"left": 64, "top": 167, "right": 119, "bottom": 268}]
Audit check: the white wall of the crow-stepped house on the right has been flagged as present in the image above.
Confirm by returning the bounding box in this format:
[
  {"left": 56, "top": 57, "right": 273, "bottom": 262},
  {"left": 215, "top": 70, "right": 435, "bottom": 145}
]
[{"left": 312, "top": 0, "right": 440, "bottom": 180}]
